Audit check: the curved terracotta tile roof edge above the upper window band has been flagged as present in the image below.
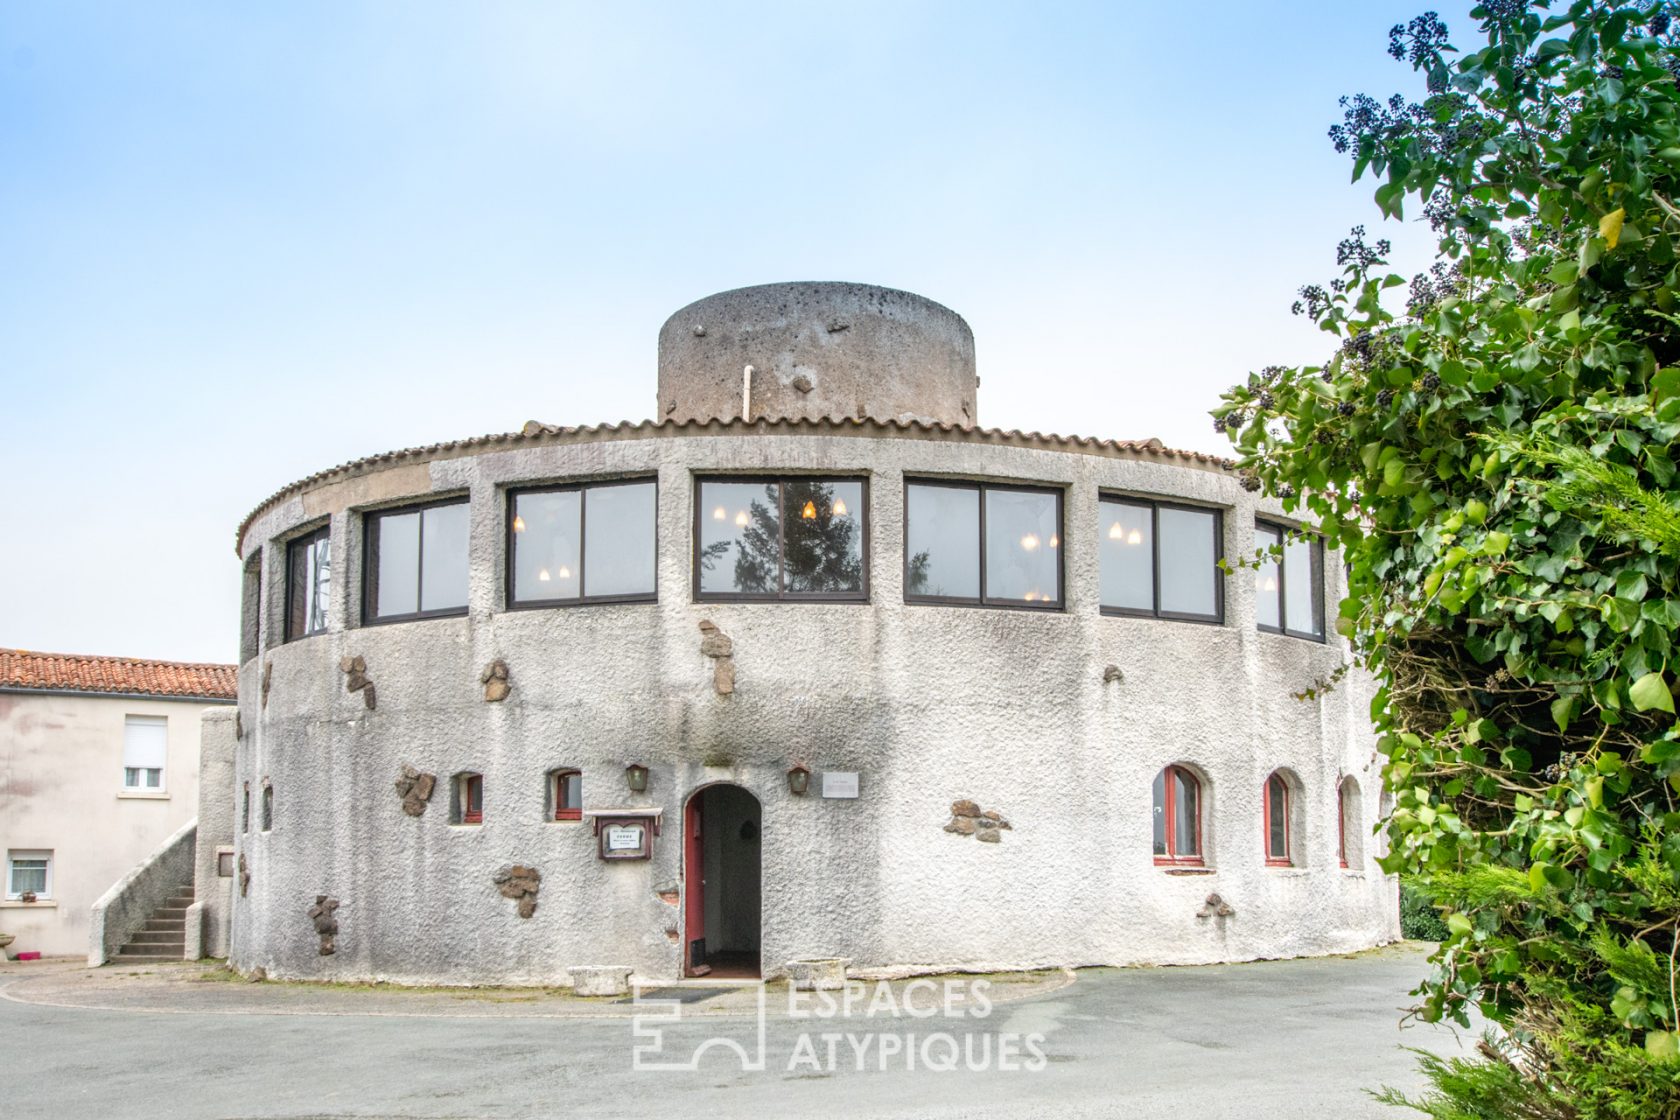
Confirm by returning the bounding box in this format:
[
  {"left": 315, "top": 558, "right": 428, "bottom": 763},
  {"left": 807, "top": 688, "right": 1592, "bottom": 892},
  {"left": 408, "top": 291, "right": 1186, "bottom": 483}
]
[{"left": 234, "top": 418, "right": 1233, "bottom": 554}]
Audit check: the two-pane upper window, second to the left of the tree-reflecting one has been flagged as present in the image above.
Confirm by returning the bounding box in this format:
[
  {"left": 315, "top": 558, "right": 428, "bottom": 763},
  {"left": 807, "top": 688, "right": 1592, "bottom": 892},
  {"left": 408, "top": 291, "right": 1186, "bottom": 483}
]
[{"left": 363, "top": 499, "right": 469, "bottom": 623}]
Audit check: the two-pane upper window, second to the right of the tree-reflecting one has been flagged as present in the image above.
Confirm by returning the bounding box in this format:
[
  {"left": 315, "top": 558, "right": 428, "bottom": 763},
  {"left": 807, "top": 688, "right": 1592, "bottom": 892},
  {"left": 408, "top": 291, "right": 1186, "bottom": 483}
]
[{"left": 1097, "top": 497, "right": 1225, "bottom": 623}]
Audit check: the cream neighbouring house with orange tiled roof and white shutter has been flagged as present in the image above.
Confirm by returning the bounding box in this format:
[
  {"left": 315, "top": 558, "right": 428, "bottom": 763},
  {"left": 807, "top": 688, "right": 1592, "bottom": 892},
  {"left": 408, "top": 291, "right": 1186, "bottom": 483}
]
[{"left": 0, "top": 650, "right": 235, "bottom": 957}]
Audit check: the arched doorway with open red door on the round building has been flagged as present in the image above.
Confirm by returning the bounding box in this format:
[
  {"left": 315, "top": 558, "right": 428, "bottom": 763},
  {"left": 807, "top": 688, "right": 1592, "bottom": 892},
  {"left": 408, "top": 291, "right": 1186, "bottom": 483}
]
[{"left": 682, "top": 784, "right": 763, "bottom": 979}]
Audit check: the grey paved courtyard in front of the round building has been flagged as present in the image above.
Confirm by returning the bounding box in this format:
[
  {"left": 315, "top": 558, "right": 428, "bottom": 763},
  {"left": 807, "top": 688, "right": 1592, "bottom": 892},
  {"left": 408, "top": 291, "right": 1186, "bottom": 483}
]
[{"left": 0, "top": 945, "right": 1473, "bottom": 1120}]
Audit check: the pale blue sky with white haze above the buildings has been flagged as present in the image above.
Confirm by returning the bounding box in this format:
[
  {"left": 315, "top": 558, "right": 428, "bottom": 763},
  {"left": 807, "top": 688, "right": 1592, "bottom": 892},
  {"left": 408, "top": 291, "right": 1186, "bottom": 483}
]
[{"left": 0, "top": 0, "right": 1472, "bottom": 662}]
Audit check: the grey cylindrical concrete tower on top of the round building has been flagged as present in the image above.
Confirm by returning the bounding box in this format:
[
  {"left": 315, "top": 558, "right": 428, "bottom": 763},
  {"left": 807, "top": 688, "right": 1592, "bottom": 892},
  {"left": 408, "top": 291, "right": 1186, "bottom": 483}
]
[{"left": 655, "top": 282, "right": 979, "bottom": 428}]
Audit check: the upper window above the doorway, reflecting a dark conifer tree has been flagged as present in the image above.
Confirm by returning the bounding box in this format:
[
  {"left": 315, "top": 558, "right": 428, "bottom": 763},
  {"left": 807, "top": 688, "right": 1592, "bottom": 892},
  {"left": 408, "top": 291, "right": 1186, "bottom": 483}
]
[{"left": 694, "top": 479, "right": 869, "bottom": 603}]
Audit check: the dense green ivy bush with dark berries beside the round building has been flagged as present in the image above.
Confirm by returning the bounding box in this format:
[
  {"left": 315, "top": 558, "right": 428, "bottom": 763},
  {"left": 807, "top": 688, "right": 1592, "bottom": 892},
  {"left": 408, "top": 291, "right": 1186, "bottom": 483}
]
[{"left": 1213, "top": 0, "right": 1680, "bottom": 1120}]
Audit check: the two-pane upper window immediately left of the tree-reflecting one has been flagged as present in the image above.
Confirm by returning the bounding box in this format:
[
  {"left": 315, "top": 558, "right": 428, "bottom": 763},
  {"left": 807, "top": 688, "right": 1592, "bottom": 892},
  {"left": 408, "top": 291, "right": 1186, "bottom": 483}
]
[{"left": 507, "top": 479, "right": 659, "bottom": 608}]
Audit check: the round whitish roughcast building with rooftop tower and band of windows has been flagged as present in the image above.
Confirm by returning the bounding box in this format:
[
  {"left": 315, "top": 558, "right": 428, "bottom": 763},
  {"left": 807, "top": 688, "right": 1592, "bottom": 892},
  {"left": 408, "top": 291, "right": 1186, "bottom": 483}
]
[{"left": 230, "top": 284, "right": 1398, "bottom": 984}]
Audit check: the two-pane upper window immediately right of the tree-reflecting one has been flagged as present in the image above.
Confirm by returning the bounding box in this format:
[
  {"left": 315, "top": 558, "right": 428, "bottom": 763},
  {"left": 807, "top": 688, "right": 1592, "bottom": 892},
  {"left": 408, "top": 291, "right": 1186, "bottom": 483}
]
[{"left": 904, "top": 482, "right": 1062, "bottom": 610}]
